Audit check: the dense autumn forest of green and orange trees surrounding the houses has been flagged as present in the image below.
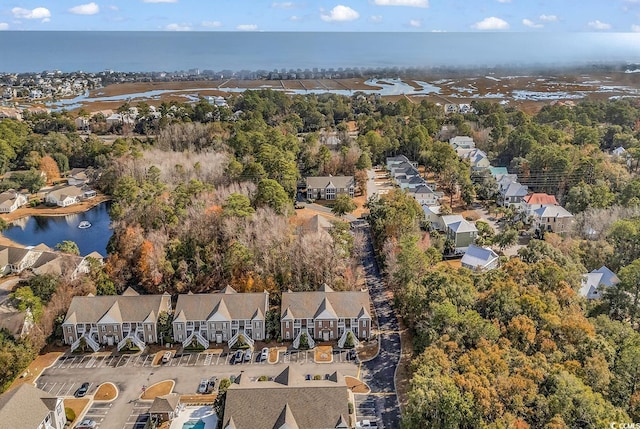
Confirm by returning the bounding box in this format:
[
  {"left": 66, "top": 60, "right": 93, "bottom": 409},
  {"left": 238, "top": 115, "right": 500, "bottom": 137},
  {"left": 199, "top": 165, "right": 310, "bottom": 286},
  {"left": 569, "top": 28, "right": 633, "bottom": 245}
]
[{"left": 0, "top": 90, "right": 640, "bottom": 428}]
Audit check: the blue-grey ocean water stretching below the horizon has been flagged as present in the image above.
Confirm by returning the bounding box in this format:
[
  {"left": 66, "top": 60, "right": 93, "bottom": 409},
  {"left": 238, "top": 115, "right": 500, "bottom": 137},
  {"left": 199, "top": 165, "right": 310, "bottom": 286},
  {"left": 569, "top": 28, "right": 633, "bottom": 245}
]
[{"left": 0, "top": 31, "right": 640, "bottom": 72}]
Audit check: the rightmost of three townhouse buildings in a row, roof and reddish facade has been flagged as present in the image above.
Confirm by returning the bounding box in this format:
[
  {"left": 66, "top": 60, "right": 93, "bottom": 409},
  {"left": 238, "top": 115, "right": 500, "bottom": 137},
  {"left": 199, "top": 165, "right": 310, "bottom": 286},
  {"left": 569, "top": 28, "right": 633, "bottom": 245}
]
[{"left": 280, "top": 285, "right": 371, "bottom": 348}]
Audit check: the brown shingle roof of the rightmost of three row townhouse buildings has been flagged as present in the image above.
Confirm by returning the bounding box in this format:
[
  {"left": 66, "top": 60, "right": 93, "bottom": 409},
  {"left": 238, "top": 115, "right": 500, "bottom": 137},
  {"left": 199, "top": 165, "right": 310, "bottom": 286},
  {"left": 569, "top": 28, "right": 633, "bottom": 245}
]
[{"left": 281, "top": 290, "right": 371, "bottom": 319}]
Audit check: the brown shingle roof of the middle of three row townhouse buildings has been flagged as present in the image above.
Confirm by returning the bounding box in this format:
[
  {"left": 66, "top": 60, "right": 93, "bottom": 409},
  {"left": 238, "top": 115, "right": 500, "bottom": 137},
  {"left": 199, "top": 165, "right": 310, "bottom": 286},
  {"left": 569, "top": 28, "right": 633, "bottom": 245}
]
[{"left": 175, "top": 292, "right": 268, "bottom": 320}]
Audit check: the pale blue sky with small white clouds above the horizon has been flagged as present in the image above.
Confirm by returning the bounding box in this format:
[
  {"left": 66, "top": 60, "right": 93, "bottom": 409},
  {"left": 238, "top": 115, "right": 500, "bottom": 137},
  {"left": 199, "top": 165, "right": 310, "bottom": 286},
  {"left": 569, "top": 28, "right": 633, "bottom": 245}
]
[{"left": 0, "top": 0, "right": 640, "bottom": 32}]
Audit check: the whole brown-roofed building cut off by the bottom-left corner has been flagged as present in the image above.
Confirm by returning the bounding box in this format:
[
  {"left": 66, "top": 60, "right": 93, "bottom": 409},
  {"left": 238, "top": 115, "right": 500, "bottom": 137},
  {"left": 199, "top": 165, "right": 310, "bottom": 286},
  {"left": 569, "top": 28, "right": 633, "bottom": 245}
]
[{"left": 0, "top": 383, "right": 67, "bottom": 429}]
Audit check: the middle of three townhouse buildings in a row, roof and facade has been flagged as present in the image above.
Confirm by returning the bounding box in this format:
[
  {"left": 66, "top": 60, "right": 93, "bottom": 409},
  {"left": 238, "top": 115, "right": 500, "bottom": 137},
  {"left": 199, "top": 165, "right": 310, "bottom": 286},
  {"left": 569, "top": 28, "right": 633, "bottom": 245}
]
[{"left": 173, "top": 286, "right": 269, "bottom": 348}]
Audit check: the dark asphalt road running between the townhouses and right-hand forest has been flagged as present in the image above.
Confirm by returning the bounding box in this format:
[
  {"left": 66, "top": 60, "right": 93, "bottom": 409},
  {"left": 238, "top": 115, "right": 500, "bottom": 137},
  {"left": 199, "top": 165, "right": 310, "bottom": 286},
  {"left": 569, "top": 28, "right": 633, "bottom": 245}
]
[{"left": 358, "top": 227, "right": 401, "bottom": 429}]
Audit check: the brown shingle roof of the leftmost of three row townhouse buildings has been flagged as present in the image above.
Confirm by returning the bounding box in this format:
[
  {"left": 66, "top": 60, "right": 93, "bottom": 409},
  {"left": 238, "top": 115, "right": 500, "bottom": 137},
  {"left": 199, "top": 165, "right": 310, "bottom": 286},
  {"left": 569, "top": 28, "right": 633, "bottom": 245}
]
[{"left": 65, "top": 294, "right": 171, "bottom": 323}]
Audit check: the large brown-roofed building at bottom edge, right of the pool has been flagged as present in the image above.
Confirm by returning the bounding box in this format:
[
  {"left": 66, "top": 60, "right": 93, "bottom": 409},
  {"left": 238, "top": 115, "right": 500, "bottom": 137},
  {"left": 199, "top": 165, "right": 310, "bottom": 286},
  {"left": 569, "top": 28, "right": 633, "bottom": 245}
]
[{"left": 222, "top": 366, "right": 353, "bottom": 429}]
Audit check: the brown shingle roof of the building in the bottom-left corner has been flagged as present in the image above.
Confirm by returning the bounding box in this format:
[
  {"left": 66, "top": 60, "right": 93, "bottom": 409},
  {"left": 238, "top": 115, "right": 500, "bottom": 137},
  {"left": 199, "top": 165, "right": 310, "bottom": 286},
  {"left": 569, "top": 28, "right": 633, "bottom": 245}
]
[{"left": 0, "top": 383, "right": 56, "bottom": 428}]
